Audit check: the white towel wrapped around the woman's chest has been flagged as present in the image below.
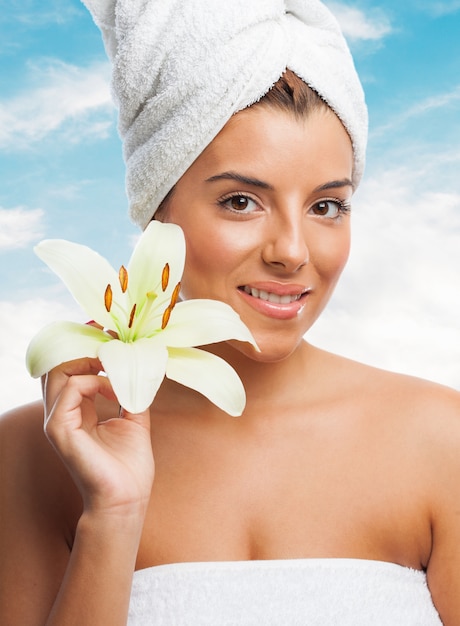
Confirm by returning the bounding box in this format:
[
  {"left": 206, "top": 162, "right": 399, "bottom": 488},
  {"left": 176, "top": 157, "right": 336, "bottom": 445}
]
[{"left": 128, "top": 559, "right": 442, "bottom": 626}]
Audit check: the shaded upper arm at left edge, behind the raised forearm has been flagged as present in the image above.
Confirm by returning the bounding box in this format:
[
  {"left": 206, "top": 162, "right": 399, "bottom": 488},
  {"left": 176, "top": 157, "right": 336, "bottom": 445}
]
[{"left": 0, "top": 403, "right": 81, "bottom": 624}]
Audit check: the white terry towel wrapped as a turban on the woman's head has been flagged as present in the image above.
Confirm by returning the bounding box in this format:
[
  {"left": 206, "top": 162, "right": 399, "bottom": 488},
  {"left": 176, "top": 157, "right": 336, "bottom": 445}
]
[{"left": 83, "top": 0, "right": 367, "bottom": 228}]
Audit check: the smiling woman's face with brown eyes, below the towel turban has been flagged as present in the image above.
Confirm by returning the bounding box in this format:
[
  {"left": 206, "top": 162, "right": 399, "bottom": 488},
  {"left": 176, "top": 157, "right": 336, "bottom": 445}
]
[{"left": 161, "top": 106, "right": 353, "bottom": 361}]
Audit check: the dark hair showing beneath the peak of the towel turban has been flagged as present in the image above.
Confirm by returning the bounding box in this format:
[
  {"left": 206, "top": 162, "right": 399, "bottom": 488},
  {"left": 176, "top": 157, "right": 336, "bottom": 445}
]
[{"left": 253, "top": 69, "right": 330, "bottom": 117}]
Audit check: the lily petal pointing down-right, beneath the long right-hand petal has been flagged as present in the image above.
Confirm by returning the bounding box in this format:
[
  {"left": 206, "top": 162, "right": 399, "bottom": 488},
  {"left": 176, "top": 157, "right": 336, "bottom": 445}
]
[{"left": 166, "top": 348, "right": 246, "bottom": 417}]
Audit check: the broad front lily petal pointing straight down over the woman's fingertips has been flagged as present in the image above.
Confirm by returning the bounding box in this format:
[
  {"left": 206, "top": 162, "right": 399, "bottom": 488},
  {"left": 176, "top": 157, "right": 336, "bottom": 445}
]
[{"left": 98, "top": 338, "right": 168, "bottom": 413}]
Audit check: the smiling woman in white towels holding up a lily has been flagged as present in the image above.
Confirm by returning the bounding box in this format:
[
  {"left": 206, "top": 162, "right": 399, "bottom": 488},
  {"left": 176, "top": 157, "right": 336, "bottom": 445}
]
[{"left": 0, "top": 2, "right": 460, "bottom": 626}]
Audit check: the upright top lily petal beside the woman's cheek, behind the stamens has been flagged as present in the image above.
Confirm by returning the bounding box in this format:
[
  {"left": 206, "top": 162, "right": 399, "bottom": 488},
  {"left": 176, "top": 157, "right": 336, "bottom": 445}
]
[{"left": 128, "top": 220, "right": 185, "bottom": 303}]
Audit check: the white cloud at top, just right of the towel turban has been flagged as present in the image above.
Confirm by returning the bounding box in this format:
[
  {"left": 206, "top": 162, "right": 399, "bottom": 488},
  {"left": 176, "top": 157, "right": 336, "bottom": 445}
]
[{"left": 327, "top": 2, "right": 392, "bottom": 41}]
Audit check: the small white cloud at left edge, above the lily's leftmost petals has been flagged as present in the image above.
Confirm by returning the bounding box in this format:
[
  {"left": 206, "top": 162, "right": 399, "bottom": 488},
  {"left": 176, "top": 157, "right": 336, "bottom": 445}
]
[{"left": 0, "top": 207, "right": 44, "bottom": 252}]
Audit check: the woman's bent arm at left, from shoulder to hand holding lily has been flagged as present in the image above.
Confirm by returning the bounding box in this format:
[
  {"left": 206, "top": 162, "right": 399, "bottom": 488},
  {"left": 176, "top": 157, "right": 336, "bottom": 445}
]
[{"left": 0, "top": 360, "right": 153, "bottom": 626}]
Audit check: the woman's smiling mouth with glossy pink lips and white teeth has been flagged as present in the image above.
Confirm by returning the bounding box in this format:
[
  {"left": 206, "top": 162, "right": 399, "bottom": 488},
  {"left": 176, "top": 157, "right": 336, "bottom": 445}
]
[{"left": 238, "top": 282, "right": 311, "bottom": 320}]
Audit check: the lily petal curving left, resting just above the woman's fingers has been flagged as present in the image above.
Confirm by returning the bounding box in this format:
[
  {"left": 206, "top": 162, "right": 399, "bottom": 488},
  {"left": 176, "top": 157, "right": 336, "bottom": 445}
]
[{"left": 26, "top": 322, "right": 113, "bottom": 378}]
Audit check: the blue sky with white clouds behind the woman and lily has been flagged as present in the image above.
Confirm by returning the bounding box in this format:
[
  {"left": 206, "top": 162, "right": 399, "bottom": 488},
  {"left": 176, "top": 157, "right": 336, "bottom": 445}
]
[{"left": 0, "top": 0, "right": 460, "bottom": 410}]
